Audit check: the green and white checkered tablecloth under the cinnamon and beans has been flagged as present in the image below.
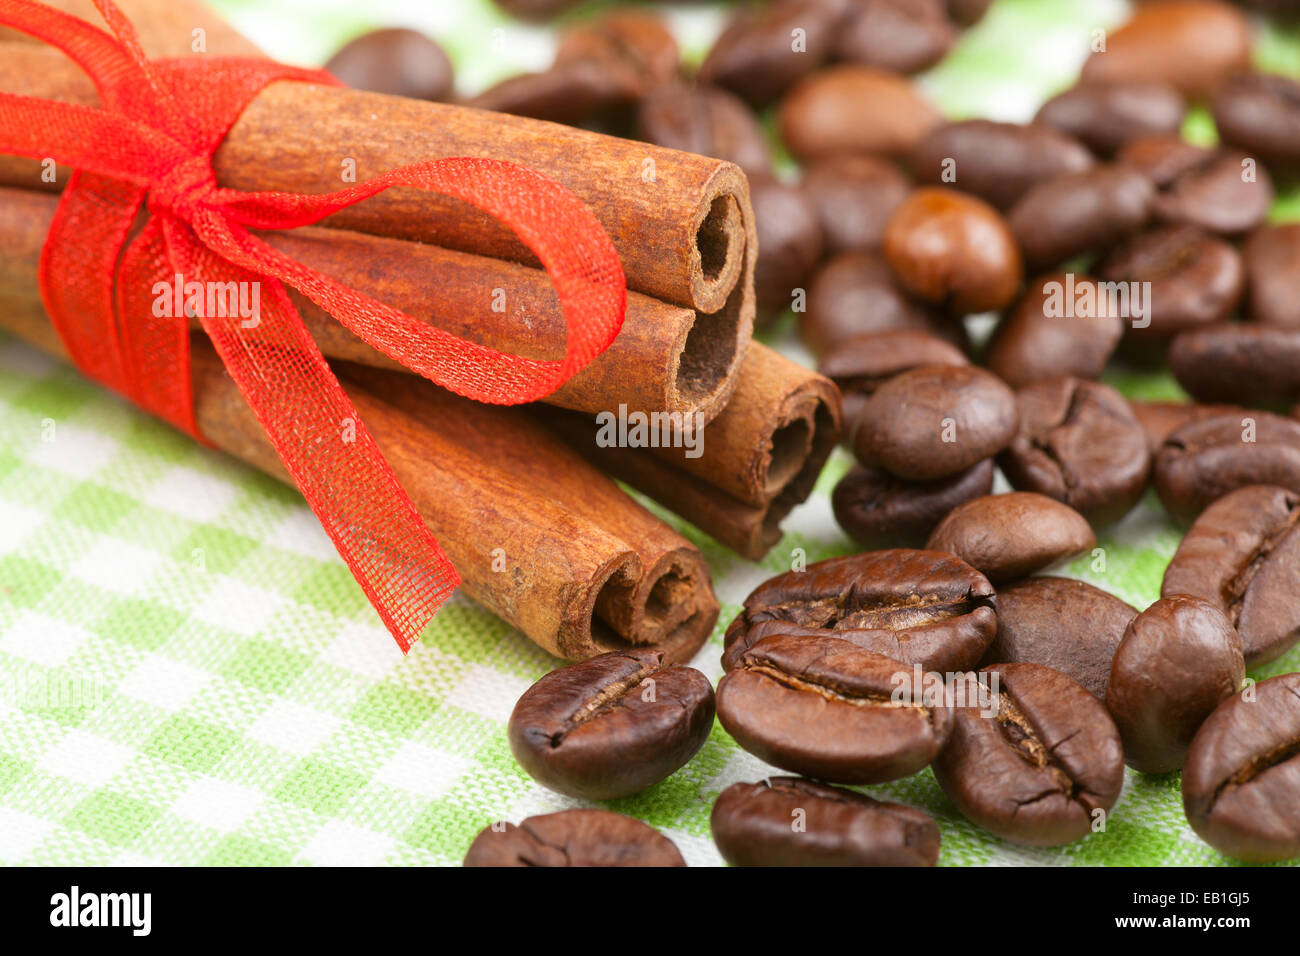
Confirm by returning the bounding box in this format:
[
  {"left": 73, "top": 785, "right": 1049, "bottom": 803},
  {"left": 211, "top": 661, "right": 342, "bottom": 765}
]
[{"left": 0, "top": 0, "right": 1300, "bottom": 865}]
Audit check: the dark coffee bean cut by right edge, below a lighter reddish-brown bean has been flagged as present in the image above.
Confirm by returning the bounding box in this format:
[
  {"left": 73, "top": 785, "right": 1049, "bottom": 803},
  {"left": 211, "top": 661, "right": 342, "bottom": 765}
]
[{"left": 1169, "top": 323, "right": 1300, "bottom": 405}]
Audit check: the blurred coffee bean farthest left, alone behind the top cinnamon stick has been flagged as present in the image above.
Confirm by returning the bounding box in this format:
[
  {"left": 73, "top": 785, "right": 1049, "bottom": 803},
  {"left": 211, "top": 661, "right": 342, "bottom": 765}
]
[{"left": 325, "top": 29, "right": 454, "bottom": 100}]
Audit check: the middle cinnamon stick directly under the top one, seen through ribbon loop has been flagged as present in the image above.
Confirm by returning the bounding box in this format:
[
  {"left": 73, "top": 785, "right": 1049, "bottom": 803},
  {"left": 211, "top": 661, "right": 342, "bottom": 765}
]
[{"left": 0, "top": 187, "right": 741, "bottom": 421}]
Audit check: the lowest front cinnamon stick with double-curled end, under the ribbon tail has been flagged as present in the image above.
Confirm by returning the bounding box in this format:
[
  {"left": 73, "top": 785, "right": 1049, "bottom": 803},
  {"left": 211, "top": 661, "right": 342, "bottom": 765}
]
[{"left": 0, "top": 295, "right": 719, "bottom": 661}]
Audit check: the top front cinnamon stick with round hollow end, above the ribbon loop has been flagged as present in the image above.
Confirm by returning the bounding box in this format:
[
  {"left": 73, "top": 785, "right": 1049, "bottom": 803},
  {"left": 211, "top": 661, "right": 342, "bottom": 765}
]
[{"left": 0, "top": 38, "right": 757, "bottom": 321}]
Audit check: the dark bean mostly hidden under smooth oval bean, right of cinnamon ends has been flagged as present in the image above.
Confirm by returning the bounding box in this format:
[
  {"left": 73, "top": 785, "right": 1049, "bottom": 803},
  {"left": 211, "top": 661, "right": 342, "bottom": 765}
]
[{"left": 831, "top": 458, "right": 993, "bottom": 549}]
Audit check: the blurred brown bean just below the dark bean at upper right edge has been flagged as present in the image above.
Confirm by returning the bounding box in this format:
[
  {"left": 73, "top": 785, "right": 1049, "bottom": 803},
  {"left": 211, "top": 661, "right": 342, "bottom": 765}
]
[{"left": 1152, "top": 150, "right": 1273, "bottom": 235}]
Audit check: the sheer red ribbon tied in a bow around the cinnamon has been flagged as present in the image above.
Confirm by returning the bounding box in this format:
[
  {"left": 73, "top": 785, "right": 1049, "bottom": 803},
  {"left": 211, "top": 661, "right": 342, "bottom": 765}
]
[{"left": 0, "top": 0, "right": 627, "bottom": 652}]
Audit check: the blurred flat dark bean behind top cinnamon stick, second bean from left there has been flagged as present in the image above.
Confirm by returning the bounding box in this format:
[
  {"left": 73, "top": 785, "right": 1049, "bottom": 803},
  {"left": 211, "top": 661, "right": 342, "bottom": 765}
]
[{"left": 468, "top": 60, "right": 628, "bottom": 126}]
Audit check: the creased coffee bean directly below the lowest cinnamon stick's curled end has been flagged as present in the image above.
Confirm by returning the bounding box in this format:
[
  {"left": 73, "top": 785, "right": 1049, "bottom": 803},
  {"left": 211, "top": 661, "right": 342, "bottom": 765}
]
[{"left": 507, "top": 648, "right": 714, "bottom": 800}]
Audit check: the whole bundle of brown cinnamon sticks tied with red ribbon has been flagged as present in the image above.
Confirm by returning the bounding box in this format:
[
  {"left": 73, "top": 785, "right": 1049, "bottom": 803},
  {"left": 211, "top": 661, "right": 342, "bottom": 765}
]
[{"left": 0, "top": 0, "right": 840, "bottom": 659}]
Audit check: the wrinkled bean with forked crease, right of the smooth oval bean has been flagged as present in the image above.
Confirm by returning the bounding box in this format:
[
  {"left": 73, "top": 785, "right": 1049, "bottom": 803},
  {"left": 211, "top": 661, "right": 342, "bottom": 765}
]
[{"left": 998, "top": 378, "right": 1151, "bottom": 525}]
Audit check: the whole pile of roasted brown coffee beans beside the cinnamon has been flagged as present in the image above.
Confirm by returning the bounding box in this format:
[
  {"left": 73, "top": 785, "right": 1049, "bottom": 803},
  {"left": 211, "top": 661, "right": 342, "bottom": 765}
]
[{"left": 322, "top": 0, "right": 1300, "bottom": 866}]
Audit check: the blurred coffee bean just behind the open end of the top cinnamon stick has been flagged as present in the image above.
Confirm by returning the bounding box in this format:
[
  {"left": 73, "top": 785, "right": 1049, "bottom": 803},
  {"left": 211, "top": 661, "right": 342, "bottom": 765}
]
[{"left": 637, "top": 83, "right": 772, "bottom": 175}]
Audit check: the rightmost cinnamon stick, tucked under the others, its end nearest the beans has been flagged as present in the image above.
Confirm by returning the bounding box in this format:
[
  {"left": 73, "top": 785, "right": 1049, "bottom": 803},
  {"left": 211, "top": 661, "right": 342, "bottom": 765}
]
[{"left": 533, "top": 342, "right": 842, "bottom": 561}]
